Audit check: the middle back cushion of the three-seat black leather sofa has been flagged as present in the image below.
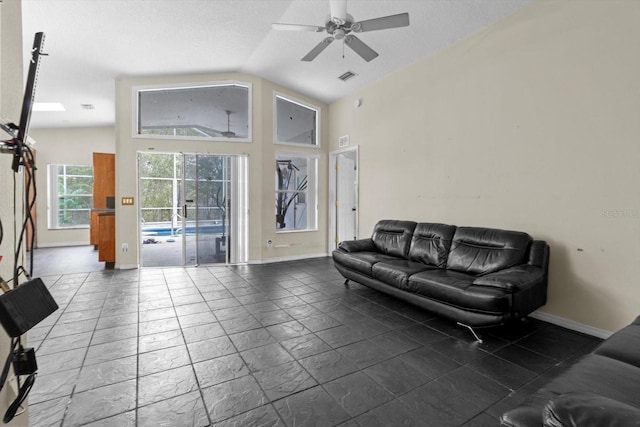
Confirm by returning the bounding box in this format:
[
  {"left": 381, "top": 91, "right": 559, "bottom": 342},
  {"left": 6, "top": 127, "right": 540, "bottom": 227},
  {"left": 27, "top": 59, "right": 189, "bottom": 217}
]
[{"left": 409, "top": 222, "right": 456, "bottom": 268}]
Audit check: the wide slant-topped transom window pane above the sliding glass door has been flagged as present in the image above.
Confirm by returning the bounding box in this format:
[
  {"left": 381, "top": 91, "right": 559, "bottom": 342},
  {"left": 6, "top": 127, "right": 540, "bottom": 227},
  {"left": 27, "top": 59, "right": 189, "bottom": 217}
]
[{"left": 136, "top": 82, "right": 251, "bottom": 141}]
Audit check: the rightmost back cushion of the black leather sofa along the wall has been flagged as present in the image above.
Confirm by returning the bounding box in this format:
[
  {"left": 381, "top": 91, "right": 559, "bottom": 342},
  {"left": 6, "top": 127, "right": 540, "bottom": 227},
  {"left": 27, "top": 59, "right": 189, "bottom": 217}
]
[{"left": 447, "top": 227, "right": 533, "bottom": 275}]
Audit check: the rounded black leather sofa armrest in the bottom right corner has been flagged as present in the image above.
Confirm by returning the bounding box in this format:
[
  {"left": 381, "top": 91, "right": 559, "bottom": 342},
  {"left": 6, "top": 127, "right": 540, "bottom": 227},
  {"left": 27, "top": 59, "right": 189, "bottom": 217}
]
[{"left": 543, "top": 393, "right": 640, "bottom": 427}]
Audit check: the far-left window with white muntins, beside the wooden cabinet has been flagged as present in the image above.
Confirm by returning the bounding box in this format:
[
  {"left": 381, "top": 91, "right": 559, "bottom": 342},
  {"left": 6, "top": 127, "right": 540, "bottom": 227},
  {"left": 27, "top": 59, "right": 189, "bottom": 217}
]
[{"left": 47, "top": 165, "right": 93, "bottom": 229}]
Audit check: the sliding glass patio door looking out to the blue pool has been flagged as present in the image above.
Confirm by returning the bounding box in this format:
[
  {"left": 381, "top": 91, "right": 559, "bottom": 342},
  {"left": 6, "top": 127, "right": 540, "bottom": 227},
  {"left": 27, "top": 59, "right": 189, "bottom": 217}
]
[{"left": 138, "top": 152, "right": 247, "bottom": 267}]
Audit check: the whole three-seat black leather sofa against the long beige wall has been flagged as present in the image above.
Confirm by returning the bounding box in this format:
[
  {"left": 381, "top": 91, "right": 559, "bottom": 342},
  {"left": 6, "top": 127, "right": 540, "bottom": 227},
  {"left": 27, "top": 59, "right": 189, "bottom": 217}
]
[{"left": 332, "top": 220, "right": 549, "bottom": 338}]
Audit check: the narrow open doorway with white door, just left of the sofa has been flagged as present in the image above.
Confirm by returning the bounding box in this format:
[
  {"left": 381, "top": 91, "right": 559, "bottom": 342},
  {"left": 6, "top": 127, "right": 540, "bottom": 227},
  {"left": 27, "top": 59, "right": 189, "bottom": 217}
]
[{"left": 329, "top": 147, "right": 358, "bottom": 250}]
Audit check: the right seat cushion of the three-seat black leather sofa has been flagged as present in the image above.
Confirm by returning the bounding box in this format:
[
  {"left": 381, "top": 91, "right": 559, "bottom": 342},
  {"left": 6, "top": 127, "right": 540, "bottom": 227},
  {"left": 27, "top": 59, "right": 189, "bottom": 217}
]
[{"left": 407, "top": 270, "right": 512, "bottom": 313}]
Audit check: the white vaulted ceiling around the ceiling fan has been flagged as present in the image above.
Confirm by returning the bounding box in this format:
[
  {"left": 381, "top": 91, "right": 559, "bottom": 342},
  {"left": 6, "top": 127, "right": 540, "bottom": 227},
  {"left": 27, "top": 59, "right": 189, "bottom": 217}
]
[{"left": 22, "top": 0, "right": 532, "bottom": 127}]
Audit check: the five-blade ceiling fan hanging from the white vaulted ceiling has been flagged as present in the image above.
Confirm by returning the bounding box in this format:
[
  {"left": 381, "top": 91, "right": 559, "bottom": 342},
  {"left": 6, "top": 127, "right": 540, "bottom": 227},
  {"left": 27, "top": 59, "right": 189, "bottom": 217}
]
[{"left": 271, "top": 0, "right": 409, "bottom": 62}]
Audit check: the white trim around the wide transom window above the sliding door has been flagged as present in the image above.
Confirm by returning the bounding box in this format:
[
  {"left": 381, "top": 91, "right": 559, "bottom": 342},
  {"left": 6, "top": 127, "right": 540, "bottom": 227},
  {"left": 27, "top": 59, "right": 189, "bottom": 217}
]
[{"left": 131, "top": 80, "right": 253, "bottom": 142}]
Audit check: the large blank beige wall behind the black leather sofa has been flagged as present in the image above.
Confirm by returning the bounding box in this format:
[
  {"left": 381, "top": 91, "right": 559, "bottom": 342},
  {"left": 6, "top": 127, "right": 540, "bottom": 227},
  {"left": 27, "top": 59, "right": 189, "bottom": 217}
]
[{"left": 329, "top": 0, "right": 640, "bottom": 331}]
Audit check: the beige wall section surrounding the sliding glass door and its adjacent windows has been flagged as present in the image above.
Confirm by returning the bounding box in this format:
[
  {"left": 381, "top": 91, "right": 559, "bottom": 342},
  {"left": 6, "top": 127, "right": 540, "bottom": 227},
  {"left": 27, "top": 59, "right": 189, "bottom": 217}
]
[{"left": 116, "top": 73, "right": 328, "bottom": 268}]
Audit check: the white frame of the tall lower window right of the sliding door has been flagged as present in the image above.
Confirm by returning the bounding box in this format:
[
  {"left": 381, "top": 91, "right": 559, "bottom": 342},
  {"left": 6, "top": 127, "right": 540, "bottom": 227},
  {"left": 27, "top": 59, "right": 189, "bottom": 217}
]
[{"left": 273, "top": 151, "right": 320, "bottom": 234}]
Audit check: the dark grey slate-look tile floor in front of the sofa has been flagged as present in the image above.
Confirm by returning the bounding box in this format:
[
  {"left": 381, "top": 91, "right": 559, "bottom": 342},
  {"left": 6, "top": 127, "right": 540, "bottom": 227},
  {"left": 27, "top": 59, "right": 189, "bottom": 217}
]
[{"left": 29, "top": 258, "right": 599, "bottom": 427}]
